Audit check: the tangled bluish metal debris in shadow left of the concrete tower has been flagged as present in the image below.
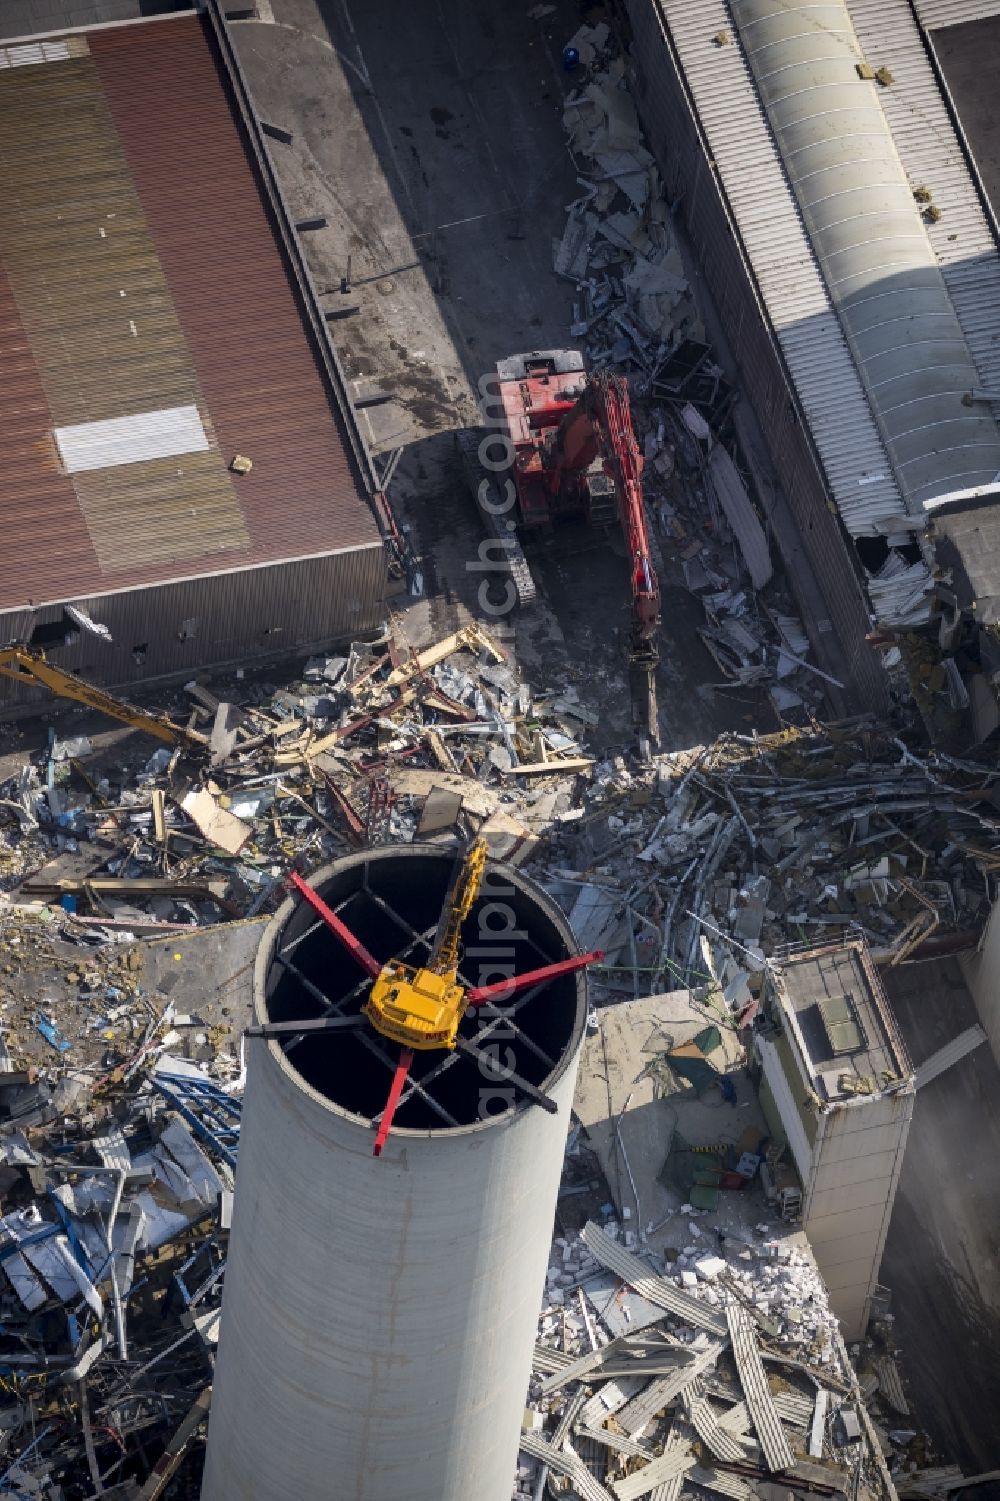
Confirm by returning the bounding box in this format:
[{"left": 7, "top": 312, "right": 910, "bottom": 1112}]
[{"left": 0, "top": 1038, "right": 231, "bottom": 1501}]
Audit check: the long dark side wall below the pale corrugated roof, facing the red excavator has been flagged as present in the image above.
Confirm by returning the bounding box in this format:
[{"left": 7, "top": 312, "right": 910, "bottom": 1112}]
[{"left": 625, "top": 0, "right": 887, "bottom": 713}]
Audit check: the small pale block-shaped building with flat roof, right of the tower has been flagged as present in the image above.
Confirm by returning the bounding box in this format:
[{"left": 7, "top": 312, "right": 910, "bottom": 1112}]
[{"left": 754, "top": 940, "right": 914, "bottom": 1340}]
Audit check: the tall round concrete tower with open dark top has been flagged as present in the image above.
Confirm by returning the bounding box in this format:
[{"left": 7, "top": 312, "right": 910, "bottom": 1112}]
[{"left": 203, "top": 847, "right": 586, "bottom": 1501}]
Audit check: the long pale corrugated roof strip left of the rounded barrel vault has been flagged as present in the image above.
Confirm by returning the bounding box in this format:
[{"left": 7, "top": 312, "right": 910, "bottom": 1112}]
[{"left": 658, "top": 0, "right": 916, "bottom": 537}]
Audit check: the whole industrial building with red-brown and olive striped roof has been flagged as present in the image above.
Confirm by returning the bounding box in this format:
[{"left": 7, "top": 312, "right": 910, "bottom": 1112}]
[{"left": 0, "top": 6, "right": 386, "bottom": 705}]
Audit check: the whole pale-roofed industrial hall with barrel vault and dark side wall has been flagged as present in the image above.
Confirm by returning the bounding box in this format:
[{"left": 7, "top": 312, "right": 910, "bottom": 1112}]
[{"left": 622, "top": 0, "right": 1000, "bottom": 711}]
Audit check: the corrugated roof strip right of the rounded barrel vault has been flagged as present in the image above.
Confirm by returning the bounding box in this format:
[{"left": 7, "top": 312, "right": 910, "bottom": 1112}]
[{"left": 847, "top": 0, "right": 1000, "bottom": 387}]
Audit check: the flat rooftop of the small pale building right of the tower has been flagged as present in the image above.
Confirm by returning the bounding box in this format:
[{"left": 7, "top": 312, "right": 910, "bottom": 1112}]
[{"left": 773, "top": 943, "right": 911, "bottom": 1102}]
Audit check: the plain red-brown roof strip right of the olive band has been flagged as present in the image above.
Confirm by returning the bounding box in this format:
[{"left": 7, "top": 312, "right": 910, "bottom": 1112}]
[{"left": 92, "top": 17, "right": 377, "bottom": 557}]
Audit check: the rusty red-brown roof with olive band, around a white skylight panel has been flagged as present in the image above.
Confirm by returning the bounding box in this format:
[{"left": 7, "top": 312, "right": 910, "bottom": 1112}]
[{"left": 0, "top": 15, "right": 378, "bottom": 609}]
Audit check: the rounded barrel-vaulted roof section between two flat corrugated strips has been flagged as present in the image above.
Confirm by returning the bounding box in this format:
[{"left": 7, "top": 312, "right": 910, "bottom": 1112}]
[{"left": 733, "top": 0, "right": 1000, "bottom": 518}]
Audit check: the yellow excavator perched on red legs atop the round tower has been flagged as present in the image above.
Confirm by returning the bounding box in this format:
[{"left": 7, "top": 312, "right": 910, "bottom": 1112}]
[{"left": 363, "top": 839, "right": 486, "bottom": 1051}]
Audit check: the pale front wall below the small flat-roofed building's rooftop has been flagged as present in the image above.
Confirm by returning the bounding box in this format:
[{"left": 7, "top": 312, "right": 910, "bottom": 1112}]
[{"left": 802, "top": 1091, "right": 914, "bottom": 1340}]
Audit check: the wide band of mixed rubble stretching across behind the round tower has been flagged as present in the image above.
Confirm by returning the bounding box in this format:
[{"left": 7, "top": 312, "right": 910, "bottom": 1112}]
[{"left": 0, "top": 617, "right": 1000, "bottom": 1010}]
